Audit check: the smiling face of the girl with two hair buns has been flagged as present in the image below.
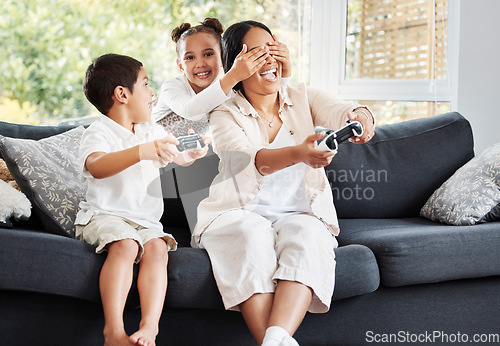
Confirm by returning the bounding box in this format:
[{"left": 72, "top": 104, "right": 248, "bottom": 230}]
[{"left": 177, "top": 32, "right": 222, "bottom": 93}]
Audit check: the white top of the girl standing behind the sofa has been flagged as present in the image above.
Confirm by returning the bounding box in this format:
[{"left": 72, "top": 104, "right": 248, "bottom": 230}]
[{"left": 151, "top": 74, "right": 232, "bottom": 121}]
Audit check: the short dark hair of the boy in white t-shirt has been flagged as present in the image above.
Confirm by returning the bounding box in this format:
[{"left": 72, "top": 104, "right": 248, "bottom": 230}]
[{"left": 83, "top": 54, "right": 142, "bottom": 115}]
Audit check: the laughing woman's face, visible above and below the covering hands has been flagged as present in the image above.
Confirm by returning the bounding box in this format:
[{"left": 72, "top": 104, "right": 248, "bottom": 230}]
[{"left": 242, "top": 27, "right": 281, "bottom": 95}]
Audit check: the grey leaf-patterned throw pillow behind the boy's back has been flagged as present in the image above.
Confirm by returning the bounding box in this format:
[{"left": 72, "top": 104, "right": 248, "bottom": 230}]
[{"left": 0, "top": 126, "right": 85, "bottom": 237}]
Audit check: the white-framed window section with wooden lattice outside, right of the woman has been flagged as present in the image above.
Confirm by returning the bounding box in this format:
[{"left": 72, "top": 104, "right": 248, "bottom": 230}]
[{"left": 310, "top": 0, "right": 454, "bottom": 124}]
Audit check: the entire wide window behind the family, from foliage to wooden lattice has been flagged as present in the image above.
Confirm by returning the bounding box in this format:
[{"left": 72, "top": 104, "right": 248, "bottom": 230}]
[{"left": 0, "top": 0, "right": 457, "bottom": 124}]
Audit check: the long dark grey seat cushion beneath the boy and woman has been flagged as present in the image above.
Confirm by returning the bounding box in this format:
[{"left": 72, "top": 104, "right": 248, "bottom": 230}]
[{"left": 0, "top": 229, "right": 379, "bottom": 309}]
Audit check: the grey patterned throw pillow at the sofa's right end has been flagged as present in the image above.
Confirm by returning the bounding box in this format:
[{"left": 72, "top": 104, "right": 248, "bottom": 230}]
[{"left": 420, "top": 143, "right": 500, "bottom": 225}]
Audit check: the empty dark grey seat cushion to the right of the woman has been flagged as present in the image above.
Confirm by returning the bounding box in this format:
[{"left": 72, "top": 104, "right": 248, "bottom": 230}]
[{"left": 338, "top": 217, "right": 500, "bottom": 286}]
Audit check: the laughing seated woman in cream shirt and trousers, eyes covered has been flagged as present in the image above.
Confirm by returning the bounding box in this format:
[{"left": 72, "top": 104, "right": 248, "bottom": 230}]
[{"left": 192, "top": 21, "right": 375, "bottom": 345}]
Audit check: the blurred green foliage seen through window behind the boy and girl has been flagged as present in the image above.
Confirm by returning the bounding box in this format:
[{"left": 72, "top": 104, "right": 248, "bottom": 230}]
[{"left": 0, "top": 0, "right": 309, "bottom": 124}]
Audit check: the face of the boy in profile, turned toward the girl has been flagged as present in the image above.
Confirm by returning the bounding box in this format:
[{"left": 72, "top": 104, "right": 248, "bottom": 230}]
[{"left": 129, "top": 67, "right": 155, "bottom": 124}]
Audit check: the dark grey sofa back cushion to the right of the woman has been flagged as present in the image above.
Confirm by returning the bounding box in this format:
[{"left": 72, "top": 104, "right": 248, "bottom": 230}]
[{"left": 325, "top": 113, "right": 474, "bottom": 219}]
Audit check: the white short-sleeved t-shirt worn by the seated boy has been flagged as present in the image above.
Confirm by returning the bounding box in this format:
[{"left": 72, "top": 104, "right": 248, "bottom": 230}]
[{"left": 75, "top": 115, "right": 167, "bottom": 230}]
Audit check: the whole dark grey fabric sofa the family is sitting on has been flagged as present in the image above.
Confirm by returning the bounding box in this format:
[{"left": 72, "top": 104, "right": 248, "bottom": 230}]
[{"left": 0, "top": 113, "right": 500, "bottom": 345}]
